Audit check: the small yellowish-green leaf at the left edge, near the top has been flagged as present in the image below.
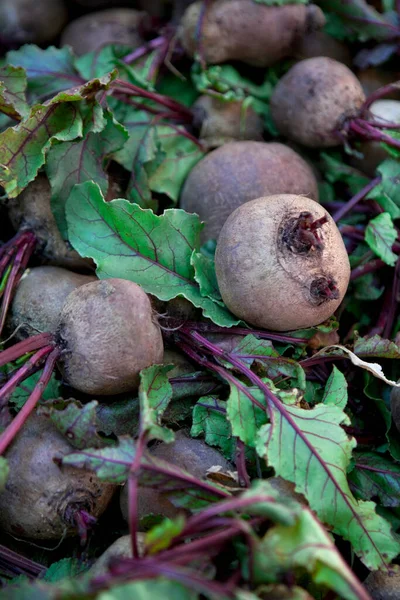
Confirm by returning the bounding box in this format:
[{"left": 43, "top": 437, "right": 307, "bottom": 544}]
[{"left": 0, "top": 65, "right": 29, "bottom": 120}]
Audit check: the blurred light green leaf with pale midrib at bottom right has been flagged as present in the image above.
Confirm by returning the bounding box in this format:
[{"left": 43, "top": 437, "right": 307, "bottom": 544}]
[{"left": 254, "top": 482, "right": 365, "bottom": 600}]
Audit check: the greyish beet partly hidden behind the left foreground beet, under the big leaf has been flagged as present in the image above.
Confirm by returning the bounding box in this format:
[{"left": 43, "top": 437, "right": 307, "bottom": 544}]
[{"left": 8, "top": 266, "right": 96, "bottom": 339}]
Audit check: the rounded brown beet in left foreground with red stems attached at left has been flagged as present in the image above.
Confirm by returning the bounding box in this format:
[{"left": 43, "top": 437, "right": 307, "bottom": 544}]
[{"left": 56, "top": 279, "right": 164, "bottom": 395}]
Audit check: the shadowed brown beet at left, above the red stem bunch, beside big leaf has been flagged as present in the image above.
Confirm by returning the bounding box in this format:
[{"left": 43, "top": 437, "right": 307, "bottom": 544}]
[{"left": 8, "top": 175, "right": 88, "bottom": 269}]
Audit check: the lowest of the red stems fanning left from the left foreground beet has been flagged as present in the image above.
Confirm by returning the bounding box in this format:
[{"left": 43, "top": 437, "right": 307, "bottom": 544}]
[{"left": 0, "top": 346, "right": 60, "bottom": 456}]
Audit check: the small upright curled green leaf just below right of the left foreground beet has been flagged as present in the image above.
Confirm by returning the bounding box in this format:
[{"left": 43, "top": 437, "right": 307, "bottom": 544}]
[{"left": 139, "top": 365, "right": 175, "bottom": 443}]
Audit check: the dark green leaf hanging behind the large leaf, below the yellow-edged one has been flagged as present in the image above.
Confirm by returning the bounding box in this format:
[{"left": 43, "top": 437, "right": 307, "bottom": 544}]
[{"left": 46, "top": 106, "right": 128, "bottom": 239}]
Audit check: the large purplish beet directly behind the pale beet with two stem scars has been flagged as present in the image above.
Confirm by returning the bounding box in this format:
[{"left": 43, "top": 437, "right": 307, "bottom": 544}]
[{"left": 180, "top": 142, "right": 318, "bottom": 241}]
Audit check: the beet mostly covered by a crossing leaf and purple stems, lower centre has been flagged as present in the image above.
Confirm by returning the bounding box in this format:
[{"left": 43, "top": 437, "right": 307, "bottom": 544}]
[{"left": 120, "top": 430, "right": 233, "bottom": 520}]
